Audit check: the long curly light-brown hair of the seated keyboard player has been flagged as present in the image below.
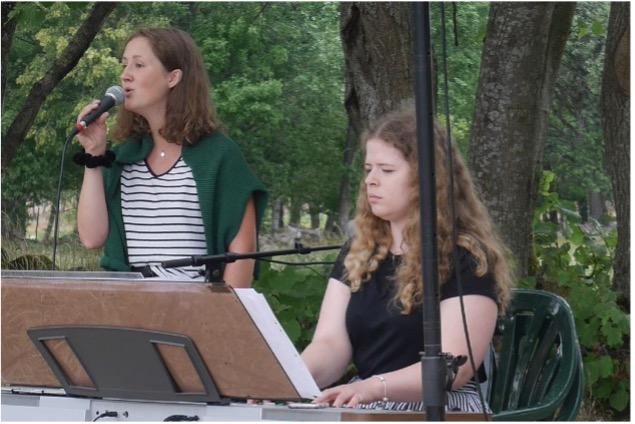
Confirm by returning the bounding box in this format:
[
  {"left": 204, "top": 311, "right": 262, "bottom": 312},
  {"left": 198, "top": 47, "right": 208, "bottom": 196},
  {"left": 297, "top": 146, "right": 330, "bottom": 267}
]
[{"left": 344, "top": 107, "right": 514, "bottom": 314}]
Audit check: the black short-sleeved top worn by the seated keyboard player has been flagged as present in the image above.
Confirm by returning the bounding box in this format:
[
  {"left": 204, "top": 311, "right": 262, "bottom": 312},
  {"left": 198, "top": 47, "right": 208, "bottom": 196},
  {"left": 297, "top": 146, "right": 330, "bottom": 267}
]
[{"left": 331, "top": 243, "right": 497, "bottom": 381}]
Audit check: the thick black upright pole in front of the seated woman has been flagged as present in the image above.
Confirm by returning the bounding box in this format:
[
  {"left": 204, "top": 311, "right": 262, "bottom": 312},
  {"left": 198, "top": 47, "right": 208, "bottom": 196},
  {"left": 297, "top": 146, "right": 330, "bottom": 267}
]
[{"left": 414, "top": 2, "right": 448, "bottom": 421}]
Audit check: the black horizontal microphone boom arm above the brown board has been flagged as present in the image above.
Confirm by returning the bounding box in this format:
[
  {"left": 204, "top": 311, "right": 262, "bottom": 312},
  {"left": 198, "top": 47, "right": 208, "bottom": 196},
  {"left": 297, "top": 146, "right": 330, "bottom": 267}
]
[{"left": 161, "top": 239, "right": 342, "bottom": 285}]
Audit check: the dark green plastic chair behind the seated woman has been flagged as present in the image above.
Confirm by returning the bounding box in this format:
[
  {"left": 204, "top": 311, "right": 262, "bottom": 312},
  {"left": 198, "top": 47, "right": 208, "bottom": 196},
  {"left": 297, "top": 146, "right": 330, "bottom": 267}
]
[{"left": 488, "top": 289, "right": 584, "bottom": 421}]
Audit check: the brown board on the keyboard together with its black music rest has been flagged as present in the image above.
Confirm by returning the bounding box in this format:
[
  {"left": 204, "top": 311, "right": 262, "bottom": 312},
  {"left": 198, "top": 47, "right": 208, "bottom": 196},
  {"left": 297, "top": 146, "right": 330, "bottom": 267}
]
[{"left": 1, "top": 271, "right": 314, "bottom": 403}]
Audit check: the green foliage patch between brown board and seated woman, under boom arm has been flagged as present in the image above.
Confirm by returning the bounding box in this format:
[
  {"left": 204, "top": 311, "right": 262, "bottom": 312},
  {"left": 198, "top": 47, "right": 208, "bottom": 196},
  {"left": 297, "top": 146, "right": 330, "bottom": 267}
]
[{"left": 254, "top": 262, "right": 331, "bottom": 352}]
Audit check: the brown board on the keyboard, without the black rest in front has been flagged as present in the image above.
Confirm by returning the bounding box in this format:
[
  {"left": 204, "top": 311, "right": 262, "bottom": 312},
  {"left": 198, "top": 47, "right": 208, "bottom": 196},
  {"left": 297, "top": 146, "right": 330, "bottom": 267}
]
[{"left": 1, "top": 278, "right": 299, "bottom": 400}]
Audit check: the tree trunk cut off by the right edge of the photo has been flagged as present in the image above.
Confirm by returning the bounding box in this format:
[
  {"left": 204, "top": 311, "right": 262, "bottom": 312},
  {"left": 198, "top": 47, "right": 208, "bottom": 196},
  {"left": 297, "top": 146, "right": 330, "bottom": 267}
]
[{"left": 601, "top": 2, "right": 631, "bottom": 303}]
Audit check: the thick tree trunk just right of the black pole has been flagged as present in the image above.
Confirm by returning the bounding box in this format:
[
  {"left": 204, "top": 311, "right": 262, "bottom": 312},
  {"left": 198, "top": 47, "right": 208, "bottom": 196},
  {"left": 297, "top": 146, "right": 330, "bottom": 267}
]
[{"left": 469, "top": 2, "right": 576, "bottom": 277}]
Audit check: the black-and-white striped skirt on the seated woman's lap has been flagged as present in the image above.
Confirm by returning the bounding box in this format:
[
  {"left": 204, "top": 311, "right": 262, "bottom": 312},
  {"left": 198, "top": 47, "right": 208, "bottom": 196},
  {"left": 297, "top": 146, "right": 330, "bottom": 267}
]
[{"left": 356, "top": 381, "right": 492, "bottom": 414}]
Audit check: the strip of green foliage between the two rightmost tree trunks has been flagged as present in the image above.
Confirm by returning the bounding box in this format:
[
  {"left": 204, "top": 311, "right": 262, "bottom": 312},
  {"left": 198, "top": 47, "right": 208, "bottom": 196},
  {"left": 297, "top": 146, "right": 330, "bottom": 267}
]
[{"left": 544, "top": 2, "right": 610, "bottom": 219}]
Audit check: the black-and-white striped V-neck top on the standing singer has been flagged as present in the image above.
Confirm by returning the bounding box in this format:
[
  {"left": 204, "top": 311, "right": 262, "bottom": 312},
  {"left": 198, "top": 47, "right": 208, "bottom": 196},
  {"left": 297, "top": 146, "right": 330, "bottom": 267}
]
[{"left": 121, "top": 158, "right": 207, "bottom": 276}]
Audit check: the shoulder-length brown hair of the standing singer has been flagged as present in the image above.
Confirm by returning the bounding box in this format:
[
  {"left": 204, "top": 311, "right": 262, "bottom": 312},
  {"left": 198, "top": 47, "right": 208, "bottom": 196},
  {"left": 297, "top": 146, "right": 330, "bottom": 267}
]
[{"left": 114, "top": 28, "right": 220, "bottom": 144}]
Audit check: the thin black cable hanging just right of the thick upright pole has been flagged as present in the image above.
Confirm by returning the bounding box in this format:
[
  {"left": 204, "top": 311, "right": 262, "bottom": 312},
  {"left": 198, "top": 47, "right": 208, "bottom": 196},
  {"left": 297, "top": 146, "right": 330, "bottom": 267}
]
[{"left": 440, "top": 2, "right": 491, "bottom": 421}]
